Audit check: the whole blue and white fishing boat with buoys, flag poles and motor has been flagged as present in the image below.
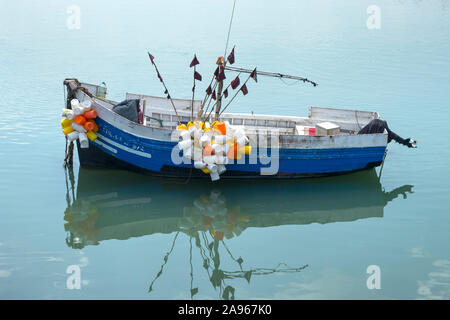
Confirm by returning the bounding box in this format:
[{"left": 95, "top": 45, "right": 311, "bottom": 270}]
[{"left": 62, "top": 1, "right": 416, "bottom": 181}]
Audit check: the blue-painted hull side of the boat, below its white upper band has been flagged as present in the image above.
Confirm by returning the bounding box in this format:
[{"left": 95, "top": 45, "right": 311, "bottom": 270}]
[{"left": 77, "top": 118, "right": 386, "bottom": 179}]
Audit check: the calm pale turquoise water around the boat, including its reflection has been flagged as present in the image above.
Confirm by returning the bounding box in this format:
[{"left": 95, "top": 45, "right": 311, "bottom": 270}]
[{"left": 0, "top": 0, "right": 450, "bottom": 299}]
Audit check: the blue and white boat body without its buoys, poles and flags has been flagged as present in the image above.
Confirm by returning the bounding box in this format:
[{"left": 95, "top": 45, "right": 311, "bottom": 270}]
[{"left": 64, "top": 79, "right": 402, "bottom": 178}]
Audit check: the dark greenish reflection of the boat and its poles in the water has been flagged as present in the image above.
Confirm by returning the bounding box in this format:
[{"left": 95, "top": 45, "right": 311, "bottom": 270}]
[{"left": 64, "top": 168, "right": 412, "bottom": 299}]
